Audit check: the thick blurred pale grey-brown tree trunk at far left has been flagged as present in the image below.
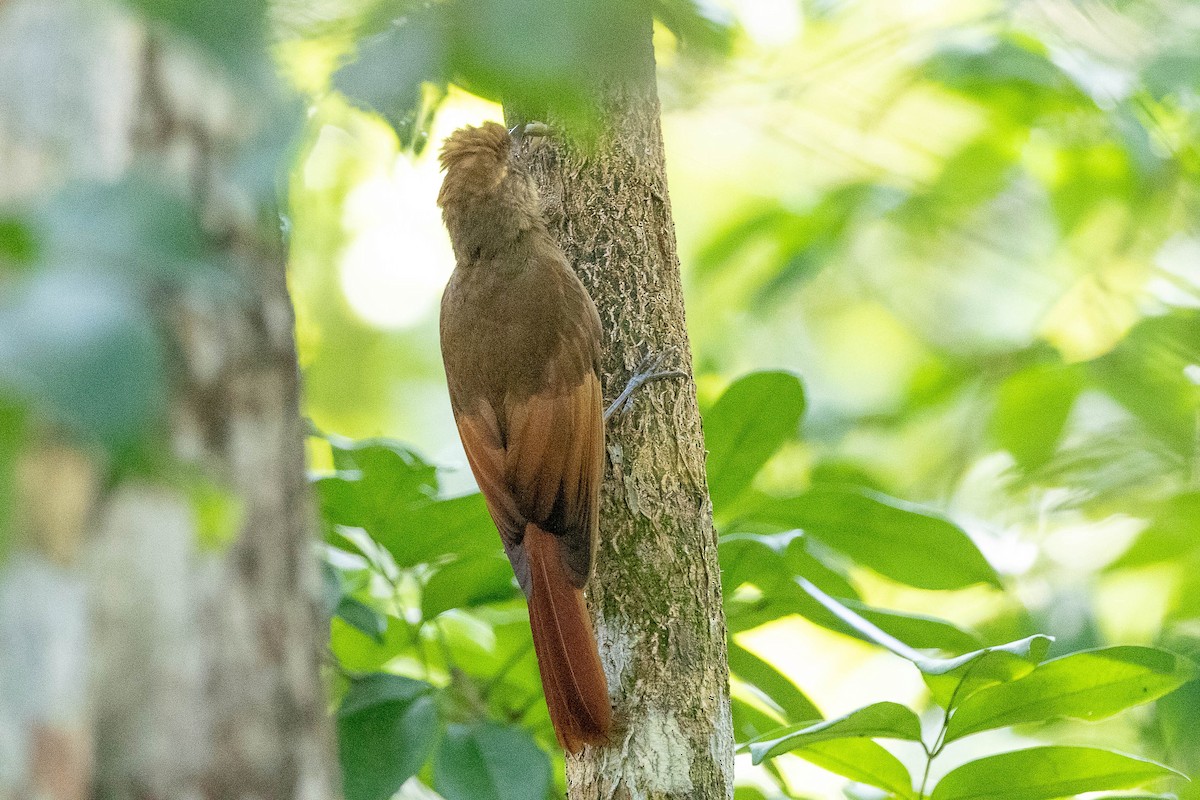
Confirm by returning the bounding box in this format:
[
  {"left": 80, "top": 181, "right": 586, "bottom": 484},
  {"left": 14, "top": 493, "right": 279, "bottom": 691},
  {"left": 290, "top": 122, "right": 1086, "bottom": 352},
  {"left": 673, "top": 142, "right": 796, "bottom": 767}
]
[{"left": 0, "top": 0, "right": 336, "bottom": 800}]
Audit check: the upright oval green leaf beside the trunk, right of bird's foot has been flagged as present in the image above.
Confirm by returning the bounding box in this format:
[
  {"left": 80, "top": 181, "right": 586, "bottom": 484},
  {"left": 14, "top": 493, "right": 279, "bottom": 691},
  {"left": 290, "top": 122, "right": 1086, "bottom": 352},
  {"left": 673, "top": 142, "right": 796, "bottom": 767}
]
[{"left": 704, "top": 372, "right": 804, "bottom": 512}]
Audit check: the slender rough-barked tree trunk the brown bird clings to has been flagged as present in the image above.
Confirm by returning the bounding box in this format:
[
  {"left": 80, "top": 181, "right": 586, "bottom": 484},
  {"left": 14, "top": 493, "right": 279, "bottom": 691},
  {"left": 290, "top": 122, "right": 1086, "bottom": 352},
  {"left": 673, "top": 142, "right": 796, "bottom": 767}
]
[{"left": 504, "top": 6, "right": 733, "bottom": 800}]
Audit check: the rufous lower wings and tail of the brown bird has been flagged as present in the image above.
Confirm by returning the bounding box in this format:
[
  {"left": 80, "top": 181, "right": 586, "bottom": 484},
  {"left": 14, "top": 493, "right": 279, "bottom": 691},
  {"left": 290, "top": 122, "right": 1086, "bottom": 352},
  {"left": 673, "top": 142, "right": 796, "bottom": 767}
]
[{"left": 456, "top": 372, "right": 612, "bottom": 753}]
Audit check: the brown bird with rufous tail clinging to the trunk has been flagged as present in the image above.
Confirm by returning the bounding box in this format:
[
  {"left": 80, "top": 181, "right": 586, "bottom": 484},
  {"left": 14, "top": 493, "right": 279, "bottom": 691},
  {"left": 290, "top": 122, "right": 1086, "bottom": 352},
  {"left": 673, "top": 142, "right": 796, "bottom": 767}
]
[{"left": 438, "top": 122, "right": 612, "bottom": 753}]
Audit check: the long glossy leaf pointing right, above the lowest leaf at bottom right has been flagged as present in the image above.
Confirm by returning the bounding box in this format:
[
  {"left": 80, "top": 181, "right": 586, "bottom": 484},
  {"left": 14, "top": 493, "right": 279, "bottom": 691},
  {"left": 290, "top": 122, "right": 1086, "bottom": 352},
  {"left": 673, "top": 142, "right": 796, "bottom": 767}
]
[{"left": 946, "top": 646, "right": 1196, "bottom": 741}]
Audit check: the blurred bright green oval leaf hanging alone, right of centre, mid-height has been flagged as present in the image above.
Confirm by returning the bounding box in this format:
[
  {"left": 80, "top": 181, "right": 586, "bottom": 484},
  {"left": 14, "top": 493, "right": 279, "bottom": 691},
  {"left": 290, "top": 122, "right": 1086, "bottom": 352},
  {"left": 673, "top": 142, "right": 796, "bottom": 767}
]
[{"left": 992, "top": 366, "right": 1084, "bottom": 471}]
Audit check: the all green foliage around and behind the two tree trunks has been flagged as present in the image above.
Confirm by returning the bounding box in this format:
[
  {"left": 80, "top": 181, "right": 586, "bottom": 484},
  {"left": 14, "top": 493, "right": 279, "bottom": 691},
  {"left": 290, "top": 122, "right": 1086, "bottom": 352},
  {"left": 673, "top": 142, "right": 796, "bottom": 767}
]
[{"left": 0, "top": 0, "right": 1200, "bottom": 800}]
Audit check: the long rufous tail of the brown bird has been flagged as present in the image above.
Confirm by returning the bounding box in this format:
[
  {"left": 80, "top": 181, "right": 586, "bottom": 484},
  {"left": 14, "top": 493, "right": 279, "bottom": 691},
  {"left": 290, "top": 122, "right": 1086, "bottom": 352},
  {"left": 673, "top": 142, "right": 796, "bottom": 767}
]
[{"left": 523, "top": 523, "right": 612, "bottom": 753}]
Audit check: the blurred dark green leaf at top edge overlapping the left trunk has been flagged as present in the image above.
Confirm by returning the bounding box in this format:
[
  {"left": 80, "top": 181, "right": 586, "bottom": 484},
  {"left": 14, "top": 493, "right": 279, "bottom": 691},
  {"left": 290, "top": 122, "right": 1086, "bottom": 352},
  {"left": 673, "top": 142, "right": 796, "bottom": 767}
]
[{"left": 125, "top": 0, "right": 270, "bottom": 83}]
